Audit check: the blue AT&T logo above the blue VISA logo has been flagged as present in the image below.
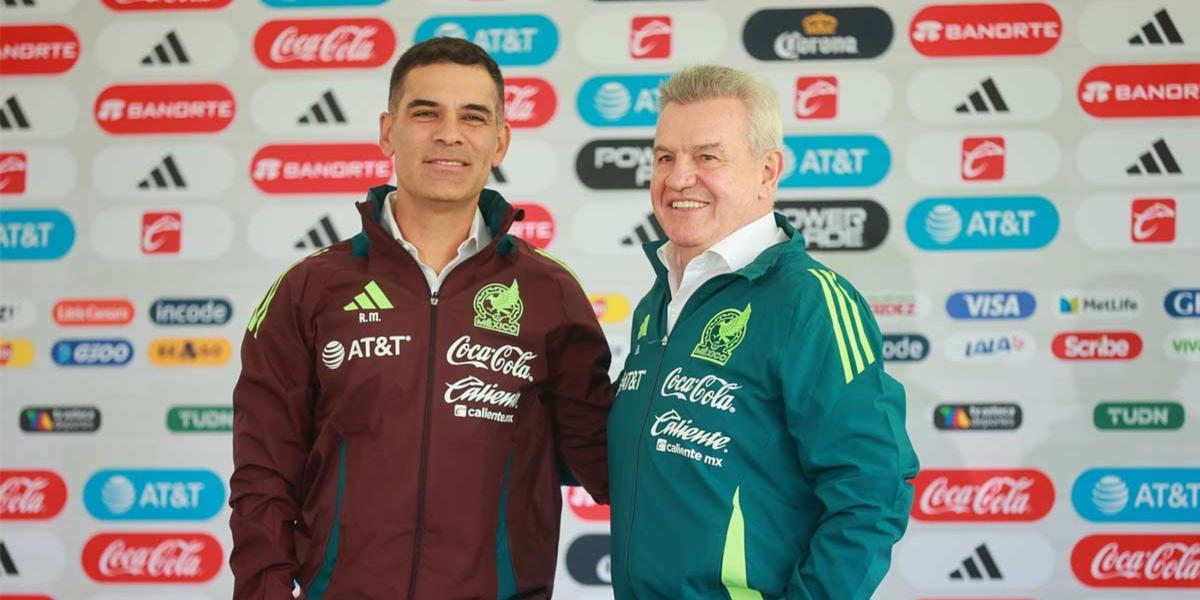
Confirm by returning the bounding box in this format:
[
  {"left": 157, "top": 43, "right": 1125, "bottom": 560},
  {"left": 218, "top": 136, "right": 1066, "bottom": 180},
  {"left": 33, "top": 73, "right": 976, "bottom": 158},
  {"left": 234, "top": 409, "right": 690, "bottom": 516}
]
[{"left": 906, "top": 196, "right": 1058, "bottom": 252}]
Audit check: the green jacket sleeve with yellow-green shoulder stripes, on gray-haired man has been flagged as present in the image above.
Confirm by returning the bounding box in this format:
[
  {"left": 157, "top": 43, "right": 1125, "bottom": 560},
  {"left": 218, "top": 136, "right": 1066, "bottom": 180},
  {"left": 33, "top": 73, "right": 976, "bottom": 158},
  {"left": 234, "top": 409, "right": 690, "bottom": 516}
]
[{"left": 782, "top": 270, "right": 918, "bottom": 600}]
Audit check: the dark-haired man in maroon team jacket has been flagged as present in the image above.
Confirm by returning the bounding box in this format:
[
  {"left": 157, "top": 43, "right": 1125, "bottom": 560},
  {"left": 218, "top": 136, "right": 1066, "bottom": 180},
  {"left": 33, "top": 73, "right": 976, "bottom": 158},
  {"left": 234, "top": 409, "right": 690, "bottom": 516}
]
[{"left": 229, "top": 38, "right": 612, "bottom": 600}]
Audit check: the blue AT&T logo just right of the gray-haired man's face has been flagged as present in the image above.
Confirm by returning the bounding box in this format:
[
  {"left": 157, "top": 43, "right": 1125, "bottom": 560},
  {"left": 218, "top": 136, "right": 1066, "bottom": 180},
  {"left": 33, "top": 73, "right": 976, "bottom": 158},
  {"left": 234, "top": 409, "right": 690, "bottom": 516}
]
[{"left": 779, "top": 136, "right": 892, "bottom": 188}]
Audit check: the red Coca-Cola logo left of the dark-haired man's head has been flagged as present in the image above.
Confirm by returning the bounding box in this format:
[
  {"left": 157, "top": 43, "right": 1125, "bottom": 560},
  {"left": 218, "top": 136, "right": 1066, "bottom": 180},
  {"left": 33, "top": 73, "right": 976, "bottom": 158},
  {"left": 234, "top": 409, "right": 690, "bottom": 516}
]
[{"left": 254, "top": 19, "right": 396, "bottom": 68}]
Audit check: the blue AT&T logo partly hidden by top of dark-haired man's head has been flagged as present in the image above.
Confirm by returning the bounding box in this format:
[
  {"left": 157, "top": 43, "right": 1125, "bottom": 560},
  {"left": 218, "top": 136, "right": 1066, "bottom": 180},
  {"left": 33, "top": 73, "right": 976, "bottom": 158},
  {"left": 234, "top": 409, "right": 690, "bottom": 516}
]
[{"left": 413, "top": 14, "right": 558, "bottom": 66}]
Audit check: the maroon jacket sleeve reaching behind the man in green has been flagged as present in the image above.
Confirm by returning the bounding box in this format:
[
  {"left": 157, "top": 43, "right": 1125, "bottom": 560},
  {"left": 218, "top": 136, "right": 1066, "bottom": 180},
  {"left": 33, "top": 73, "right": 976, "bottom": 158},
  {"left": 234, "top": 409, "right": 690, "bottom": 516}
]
[{"left": 546, "top": 270, "right": 613, "bottom": 504}]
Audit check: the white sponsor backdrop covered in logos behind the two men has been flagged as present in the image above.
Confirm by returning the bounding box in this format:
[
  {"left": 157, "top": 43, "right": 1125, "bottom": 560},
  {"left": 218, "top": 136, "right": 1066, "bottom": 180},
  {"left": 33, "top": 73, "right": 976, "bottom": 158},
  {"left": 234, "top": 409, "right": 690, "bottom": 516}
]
[{"left": 0, "top": 0, "right": 1200, "bottom": 600}]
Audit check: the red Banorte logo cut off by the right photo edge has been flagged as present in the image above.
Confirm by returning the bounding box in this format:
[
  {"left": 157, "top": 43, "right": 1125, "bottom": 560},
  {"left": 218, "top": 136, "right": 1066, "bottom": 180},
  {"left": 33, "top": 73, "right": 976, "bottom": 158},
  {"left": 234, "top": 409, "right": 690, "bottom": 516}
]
[{"left": 1078, "top": 62, "right": 1200, "bottom": 119}]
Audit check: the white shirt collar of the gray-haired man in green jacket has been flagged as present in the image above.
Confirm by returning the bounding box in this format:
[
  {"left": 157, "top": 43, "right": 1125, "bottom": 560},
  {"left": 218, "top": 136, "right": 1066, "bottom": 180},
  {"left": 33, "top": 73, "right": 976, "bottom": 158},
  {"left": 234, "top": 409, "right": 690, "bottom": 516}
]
[{"left": 658, "top": 212, "right": 787, "bottom": 335}]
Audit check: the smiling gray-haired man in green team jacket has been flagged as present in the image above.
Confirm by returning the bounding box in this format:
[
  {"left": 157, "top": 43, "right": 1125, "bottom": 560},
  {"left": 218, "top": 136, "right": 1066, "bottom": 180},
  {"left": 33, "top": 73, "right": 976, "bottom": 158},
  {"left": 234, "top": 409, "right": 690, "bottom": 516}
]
[{"left": 608, "top": 66, "right": 918, "bottom": 600}]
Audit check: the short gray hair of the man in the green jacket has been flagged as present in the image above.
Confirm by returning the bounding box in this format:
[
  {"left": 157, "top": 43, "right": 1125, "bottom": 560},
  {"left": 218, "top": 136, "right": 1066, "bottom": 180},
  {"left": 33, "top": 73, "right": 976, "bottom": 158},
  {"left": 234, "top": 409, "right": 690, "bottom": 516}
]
[{"left": 659, "top": 65, "right": 784, "bottom": 157}]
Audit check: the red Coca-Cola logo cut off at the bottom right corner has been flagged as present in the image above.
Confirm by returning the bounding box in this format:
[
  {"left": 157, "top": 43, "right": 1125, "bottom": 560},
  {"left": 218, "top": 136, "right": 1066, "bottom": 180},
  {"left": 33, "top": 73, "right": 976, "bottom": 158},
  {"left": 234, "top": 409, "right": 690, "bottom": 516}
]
[{"left": 1070, "top": 534, "right": 1200, "bottom": 589}]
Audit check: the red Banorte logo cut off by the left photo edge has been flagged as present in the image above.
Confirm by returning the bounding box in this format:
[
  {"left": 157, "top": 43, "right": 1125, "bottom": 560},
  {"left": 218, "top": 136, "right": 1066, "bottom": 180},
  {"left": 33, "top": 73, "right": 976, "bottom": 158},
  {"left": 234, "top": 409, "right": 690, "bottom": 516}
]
[{"left": 0, "top": 25, "right": 79, "bottom": 76}]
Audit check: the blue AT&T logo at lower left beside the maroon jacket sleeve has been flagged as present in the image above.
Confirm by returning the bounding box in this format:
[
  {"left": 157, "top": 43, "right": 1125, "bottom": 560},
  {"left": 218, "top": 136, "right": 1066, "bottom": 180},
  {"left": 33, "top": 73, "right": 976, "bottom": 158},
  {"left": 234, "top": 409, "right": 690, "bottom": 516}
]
[{"left": 83, "top": 469, "right": 226, "bottom": 521}]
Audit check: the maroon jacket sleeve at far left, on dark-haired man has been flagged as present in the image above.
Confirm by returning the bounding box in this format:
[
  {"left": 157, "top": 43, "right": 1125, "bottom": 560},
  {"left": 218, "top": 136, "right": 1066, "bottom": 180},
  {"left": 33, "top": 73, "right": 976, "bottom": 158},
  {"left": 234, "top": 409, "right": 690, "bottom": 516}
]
[{"left": 229, "top": 269, "right": 314, "bottom": 600}]
